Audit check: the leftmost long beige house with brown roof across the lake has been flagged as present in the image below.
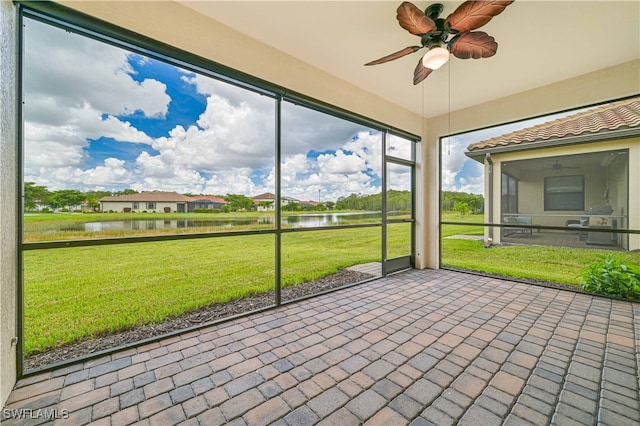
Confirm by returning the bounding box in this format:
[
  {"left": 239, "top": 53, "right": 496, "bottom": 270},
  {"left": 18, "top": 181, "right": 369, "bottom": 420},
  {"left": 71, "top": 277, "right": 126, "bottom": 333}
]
[{"left": 99, "top": 191, "right": 191, "bottom": 213}]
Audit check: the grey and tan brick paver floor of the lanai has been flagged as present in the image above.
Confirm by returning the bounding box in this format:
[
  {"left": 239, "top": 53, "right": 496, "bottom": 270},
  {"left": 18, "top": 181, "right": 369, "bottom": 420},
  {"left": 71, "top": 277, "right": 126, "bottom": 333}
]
[{"left": 2, "top": 270, "right": 640, "bottom": 426}]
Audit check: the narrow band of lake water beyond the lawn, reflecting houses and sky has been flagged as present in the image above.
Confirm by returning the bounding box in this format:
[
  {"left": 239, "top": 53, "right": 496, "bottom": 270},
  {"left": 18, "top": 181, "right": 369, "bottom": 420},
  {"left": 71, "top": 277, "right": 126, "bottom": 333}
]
[{"left": 64, "top": 212, "right": 381, "bottom": 232}]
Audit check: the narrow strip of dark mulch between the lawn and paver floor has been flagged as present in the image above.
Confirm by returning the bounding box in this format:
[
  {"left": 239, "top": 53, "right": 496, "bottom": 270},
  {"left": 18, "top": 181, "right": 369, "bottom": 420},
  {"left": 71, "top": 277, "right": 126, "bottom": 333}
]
[{"left": 24, "top": 269, "right": 373, "bottom": 370}]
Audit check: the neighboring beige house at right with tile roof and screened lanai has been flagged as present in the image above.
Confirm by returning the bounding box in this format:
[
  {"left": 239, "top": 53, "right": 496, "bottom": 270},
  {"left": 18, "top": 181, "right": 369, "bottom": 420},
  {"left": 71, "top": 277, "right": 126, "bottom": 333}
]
[{"left": 466, "top": 97, "right": 640, "bottom": 250}]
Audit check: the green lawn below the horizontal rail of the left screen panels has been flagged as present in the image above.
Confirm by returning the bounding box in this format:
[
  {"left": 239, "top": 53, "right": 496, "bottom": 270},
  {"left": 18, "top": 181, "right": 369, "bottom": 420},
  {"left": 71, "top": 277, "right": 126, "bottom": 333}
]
[{"left": 24, "top": 227, "right": 381, "bottom": 355}]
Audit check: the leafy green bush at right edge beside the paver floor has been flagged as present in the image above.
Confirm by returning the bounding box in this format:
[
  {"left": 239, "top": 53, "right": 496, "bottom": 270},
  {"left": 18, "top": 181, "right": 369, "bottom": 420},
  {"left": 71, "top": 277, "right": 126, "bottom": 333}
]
[{"left": 580, "top": 254, "right": 640, "bottom": 299}]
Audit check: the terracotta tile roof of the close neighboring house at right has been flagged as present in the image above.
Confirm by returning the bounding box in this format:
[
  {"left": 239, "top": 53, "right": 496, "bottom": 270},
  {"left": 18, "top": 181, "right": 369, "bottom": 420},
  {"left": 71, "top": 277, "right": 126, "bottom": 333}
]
[{"left": 467, "top": 97, "right": 640, "bottom": 151}]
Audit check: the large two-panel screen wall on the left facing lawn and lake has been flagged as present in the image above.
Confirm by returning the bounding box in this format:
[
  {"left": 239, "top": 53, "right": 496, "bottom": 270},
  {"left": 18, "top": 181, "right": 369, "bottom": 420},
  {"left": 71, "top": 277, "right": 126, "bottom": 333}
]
[{"left": 19, "top": 3, "right": 416, "bottom": 370}]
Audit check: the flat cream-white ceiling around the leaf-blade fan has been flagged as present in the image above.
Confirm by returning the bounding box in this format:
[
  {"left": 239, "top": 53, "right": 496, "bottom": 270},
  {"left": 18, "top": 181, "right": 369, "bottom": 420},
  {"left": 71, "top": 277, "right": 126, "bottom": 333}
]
[{"left": 182, "top": 0, "right": 640, "bottom": 117}]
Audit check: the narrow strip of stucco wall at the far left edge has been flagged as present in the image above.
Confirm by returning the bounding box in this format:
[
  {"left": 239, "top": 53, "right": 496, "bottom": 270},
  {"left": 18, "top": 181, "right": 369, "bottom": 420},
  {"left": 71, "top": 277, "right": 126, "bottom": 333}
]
[{"left": 0, "top": 1, "right": 18, "bottom": 405}]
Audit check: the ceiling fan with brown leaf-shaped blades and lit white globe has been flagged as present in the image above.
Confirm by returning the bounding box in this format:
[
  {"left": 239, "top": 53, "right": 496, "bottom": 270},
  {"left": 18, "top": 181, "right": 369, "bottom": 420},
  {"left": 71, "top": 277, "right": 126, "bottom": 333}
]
[{"left": 365, "top": 0, "right": 513, "bottom": 85}]
